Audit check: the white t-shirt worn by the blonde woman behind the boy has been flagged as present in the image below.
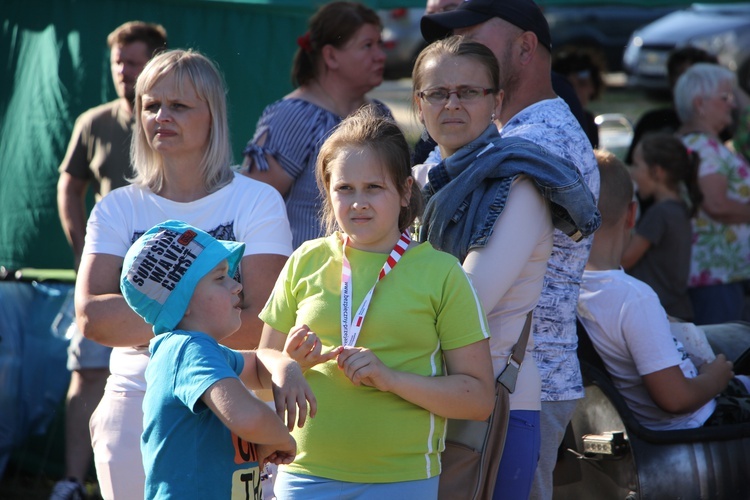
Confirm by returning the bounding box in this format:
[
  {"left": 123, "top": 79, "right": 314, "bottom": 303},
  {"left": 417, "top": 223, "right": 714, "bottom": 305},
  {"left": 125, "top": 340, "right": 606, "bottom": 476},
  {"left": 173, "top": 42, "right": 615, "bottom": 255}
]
[{"left": 83, "top": 173, "right": 292, "bottom": 391}]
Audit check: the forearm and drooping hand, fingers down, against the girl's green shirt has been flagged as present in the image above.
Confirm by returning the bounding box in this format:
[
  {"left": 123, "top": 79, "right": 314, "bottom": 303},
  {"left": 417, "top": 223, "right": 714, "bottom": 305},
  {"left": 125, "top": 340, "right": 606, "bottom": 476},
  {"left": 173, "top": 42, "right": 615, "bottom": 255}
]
[{"left": 240, "top": 349, "right": 318, "bottom": 430}]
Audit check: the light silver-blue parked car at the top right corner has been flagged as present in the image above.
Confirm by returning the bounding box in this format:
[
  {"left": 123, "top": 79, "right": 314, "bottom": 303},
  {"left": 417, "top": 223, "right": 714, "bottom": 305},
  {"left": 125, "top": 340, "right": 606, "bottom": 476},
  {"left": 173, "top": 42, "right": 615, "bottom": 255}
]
[{"left": 623, "top": 3, "right": 750, "bottom": 90}]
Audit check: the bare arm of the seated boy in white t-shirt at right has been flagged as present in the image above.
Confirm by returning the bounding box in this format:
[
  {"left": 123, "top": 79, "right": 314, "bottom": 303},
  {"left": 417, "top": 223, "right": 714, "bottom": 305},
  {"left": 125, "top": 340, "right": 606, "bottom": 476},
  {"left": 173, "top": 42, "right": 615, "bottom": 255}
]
[{"left": 641, "top": 354, "right": 734, "bottom": 414}]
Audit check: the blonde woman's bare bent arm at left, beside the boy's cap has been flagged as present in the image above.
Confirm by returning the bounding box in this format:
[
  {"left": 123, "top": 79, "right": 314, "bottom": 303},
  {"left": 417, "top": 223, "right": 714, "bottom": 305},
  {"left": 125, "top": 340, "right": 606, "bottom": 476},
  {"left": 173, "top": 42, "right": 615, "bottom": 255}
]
[{"left": 75, "top": 254, "right": 154, "bottom": 347}]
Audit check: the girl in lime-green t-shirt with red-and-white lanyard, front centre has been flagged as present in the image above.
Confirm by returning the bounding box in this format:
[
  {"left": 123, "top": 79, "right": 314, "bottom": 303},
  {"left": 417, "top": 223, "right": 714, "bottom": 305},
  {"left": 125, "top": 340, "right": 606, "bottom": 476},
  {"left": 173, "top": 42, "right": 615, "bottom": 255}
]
[{"left": 260, "top": 107, "right": 494, "bottom": 500}]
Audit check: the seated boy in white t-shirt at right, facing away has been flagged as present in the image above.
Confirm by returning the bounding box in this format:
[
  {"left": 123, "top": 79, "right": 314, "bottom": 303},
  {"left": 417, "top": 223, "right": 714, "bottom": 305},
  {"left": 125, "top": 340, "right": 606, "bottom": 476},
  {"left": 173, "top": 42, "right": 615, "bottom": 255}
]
[{"left": 578, "top": 151, "right": 750, "bottom": 430}]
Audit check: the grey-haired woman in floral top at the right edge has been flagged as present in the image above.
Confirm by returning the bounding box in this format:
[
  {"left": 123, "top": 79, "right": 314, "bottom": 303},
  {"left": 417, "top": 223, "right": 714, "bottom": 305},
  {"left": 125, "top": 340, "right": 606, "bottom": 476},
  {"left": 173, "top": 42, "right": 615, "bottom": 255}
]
[{"left": 674, "top": 63, "right": 750, "bottom": 324}]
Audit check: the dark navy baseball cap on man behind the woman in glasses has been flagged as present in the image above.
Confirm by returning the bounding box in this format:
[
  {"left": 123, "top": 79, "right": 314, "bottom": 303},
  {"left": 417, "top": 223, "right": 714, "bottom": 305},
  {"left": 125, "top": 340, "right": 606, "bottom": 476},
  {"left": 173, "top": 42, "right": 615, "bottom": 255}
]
[{"left": 420, "top": 0, "right": 552, "bottom": 51}]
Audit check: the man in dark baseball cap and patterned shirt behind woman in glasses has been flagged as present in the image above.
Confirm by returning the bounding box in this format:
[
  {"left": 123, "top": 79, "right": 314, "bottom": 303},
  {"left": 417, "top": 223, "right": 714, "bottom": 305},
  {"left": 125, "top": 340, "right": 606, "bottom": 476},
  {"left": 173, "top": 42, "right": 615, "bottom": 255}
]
[{"left": 421, "top": 0, "right": 599, "bottom": 500}]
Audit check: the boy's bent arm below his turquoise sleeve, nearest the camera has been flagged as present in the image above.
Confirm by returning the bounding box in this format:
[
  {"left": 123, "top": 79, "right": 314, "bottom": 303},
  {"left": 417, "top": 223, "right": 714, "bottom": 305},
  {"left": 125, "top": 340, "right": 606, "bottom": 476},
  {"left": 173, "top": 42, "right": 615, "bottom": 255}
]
[{"left": 201, "top": 377, "right": 297, "bottom": 458}]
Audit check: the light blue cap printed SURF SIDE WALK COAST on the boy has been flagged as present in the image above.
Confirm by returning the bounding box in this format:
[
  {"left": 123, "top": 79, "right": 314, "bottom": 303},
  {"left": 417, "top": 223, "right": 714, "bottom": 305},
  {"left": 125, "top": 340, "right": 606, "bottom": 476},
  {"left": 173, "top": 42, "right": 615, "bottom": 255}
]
[{"left": 120, "top": 220, "right": 245, "bottom": 335}]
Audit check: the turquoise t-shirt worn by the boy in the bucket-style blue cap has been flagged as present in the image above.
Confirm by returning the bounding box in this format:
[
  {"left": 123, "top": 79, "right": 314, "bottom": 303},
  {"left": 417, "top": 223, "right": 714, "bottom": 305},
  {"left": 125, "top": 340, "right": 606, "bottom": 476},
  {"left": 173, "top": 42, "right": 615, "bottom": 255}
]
[{"left": 141, "top": 330, "right": 262, "bottom": 500}]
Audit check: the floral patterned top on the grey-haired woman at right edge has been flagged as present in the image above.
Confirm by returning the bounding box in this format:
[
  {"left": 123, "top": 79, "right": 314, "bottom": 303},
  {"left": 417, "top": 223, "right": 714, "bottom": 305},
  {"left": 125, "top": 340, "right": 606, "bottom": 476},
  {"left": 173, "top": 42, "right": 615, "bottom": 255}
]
[{"left": 682, "top": 133, "right": 750, "bottom": 287}]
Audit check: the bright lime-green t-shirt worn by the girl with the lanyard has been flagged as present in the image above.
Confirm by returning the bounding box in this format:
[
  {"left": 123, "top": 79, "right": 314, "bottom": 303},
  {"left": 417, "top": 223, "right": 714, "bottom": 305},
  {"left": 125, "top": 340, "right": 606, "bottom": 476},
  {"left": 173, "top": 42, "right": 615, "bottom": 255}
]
[{"left": 260, "top": 235, "right": 489, "bottom": 483}]
